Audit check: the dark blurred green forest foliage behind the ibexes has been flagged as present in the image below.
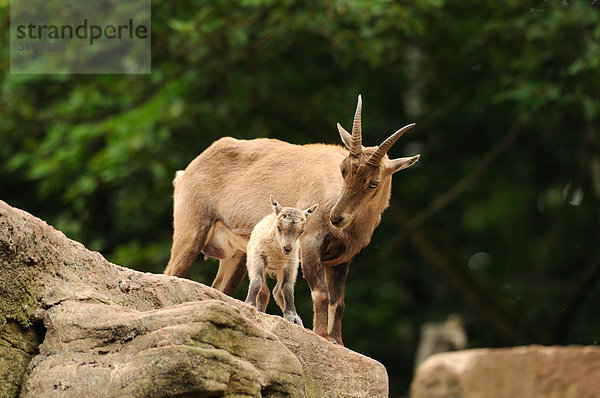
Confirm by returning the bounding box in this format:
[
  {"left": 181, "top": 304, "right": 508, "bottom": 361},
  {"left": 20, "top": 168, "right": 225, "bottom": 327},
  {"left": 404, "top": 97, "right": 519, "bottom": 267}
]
[{"left": 0, "top": 0, "right": 600, "bottom": 397}]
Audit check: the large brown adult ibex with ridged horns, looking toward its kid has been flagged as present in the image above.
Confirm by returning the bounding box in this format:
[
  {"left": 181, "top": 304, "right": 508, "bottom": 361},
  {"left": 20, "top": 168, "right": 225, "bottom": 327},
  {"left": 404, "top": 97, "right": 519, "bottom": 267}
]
[{"left": 165, "top": 96, "right": 419, "bottom": 344}]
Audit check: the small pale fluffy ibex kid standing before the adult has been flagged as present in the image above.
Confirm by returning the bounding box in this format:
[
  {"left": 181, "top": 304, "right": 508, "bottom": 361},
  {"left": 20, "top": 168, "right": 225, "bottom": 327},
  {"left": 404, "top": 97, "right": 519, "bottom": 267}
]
[{"left": 246, "top": 195, "right": 319, "bottom": 326}]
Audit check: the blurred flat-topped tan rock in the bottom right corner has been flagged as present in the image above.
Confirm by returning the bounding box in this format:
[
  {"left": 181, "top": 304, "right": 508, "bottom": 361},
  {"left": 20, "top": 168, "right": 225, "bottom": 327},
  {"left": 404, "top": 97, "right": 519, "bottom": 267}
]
[{"left": 411, "top": 345, "right": 600, "bottom": 398}]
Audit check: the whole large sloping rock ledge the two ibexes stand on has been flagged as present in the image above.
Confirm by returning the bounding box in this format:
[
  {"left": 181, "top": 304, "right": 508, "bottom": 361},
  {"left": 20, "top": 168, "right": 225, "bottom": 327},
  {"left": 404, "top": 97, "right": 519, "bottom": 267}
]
[{"left": 0, "top": 201, "right": 388, "bottom": 398}]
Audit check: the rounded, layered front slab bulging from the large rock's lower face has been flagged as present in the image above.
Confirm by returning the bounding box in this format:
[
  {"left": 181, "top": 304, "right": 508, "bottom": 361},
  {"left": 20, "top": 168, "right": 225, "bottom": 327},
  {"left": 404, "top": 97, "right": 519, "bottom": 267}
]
[{"left": 21, "top": 300, "right": 304, "bottom": 397}]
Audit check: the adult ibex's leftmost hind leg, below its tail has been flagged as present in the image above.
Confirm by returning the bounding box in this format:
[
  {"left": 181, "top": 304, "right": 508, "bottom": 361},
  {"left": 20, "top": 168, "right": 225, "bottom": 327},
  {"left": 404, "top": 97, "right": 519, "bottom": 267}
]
[{"left": 165, "top": 194, "right": 212, "bottom": 276}]
